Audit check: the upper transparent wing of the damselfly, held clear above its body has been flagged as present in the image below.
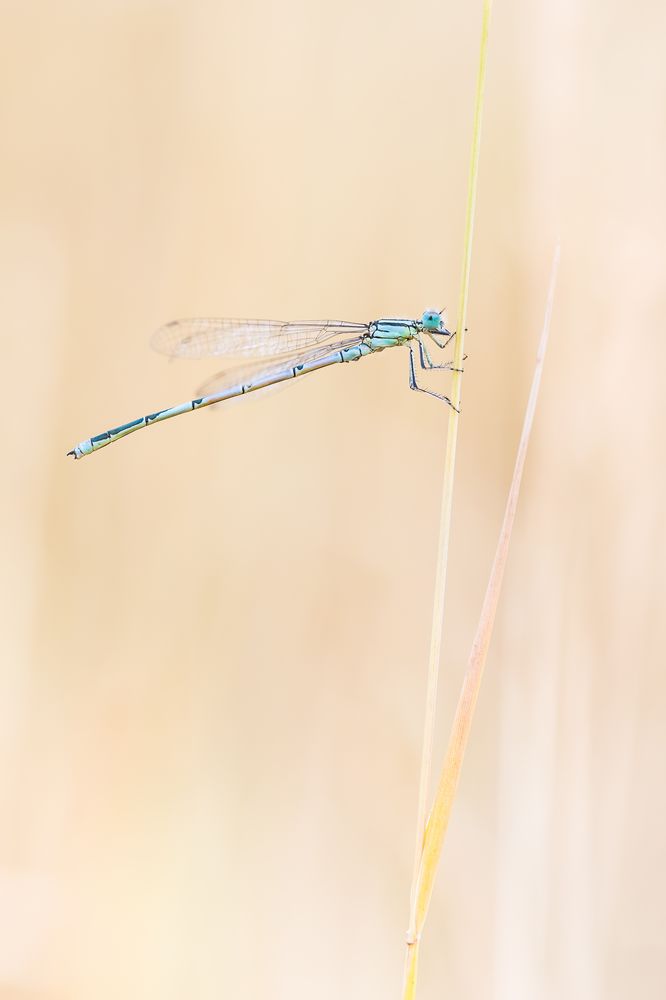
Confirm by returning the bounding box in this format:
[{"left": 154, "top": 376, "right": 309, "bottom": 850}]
[{"left": 152, "top": 319, "right": 368, "bottom": 358}]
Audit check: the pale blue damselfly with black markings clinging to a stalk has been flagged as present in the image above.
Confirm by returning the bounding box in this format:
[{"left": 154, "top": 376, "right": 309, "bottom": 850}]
[{"left": 67, "top": 310, "right": 454, "bottom": 458}]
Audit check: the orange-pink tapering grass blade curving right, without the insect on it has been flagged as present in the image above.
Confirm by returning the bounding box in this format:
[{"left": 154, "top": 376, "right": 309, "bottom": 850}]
[{"left": 403, "top": 246, "right": 560, "bottom": 1000}]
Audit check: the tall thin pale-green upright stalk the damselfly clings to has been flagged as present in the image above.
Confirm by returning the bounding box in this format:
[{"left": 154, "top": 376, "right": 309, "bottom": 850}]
[{"left": 407, "top": 0, "right": 492, "bottom": 942}]
